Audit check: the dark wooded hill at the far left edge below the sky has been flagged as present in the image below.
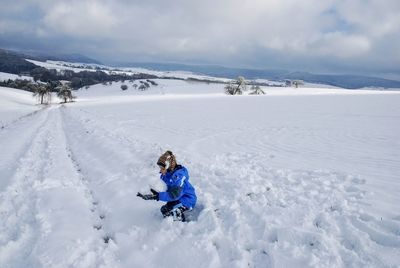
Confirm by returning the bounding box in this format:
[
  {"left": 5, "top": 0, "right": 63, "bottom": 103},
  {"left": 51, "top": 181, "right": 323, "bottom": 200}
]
[{"left": 0, "top": 49, "right": 37, "bottom": 74}]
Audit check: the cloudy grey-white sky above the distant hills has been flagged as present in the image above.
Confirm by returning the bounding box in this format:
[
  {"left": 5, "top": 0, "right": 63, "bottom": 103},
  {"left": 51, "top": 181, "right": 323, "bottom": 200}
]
[{"left": 0, "top": 0, "right": 400, "bottom": 74}]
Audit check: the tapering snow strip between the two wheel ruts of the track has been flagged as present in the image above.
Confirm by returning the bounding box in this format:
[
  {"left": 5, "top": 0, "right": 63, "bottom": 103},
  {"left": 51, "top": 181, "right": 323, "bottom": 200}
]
[{"left": 36, "top": 106, "right": 117, "bottom": 267}]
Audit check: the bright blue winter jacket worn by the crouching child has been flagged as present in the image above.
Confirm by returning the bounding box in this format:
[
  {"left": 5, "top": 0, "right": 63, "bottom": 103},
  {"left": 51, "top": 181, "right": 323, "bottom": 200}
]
[{"left": 158, "top": 165, "right": 197, "bottom": 209}]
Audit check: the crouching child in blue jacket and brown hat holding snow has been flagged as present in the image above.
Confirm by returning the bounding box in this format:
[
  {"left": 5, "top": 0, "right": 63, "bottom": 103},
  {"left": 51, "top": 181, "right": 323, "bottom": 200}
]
[{"left": 137, "top": 151, "right": 197, "bottom": 221}]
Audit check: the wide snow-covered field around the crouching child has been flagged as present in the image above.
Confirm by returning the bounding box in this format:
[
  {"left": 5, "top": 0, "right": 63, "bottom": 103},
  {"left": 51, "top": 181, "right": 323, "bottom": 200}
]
[{"left": 0, "top": 80, "right": 400, "bottom": 267}]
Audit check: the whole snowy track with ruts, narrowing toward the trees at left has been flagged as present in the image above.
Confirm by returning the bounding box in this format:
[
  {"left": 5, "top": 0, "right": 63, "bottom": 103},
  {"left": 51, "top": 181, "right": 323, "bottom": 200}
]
[{"left": 0, "top": 108, "right": 119, "bottom": 267}]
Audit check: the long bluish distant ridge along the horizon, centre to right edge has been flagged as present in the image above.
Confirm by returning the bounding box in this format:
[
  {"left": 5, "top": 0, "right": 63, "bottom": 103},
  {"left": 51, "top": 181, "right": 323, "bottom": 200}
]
[{"left": 121, "top": 63, "right": 400, "bottom": 89}]
